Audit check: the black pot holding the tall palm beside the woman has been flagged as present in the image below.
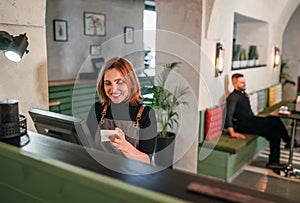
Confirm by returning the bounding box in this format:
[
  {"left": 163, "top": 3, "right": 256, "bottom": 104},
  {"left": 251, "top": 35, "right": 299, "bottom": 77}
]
[{"left": 154, "top": 132, "right": 176, "bottom": 168}]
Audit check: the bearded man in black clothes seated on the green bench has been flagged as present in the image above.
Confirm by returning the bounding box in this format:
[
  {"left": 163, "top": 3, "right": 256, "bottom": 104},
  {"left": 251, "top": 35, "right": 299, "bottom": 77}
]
[{"left": 225, "top": 73, "right": 299, "bottom": 170}]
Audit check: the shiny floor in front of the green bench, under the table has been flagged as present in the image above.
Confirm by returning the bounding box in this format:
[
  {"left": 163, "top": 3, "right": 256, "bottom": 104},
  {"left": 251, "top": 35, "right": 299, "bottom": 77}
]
[{"left": 231, "top": 135, "right": 300, "bottom": 202}]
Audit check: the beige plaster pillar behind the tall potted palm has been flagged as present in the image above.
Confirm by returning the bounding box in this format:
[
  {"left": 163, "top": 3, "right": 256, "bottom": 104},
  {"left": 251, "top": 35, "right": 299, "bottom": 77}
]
[{"left": 155, "top": 0, "right": 202, "bottom": 173}]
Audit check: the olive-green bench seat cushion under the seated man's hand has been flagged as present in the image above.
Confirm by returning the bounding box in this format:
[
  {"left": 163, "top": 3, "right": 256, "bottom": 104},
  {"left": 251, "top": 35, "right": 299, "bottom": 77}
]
[{"left": 201, "top": 133, "right": 257, "bottom": 154}]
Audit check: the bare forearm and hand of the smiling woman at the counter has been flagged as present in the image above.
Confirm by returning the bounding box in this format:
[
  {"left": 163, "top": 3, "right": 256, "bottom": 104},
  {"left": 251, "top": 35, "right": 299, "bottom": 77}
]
[{"left": 109, "top": 128, "right": 150, "bottom": 164}]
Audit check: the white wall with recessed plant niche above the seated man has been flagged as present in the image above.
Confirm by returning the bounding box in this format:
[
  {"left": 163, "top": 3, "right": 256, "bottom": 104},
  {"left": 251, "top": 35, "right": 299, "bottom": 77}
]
[{"left": 199, "top": 0, "right": 300, "bottom": 109}]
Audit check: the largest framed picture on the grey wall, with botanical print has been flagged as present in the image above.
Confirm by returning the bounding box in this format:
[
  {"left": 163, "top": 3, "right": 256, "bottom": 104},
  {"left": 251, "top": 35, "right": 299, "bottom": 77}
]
[{"left": 83, "top": 12, "right": 106, "bottom": 36}]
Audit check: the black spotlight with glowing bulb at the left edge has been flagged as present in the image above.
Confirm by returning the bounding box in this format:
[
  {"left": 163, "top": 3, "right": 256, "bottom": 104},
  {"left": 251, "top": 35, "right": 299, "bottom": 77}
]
[{"left": 0, "top": 31, "right": 29, "bottom": 62}]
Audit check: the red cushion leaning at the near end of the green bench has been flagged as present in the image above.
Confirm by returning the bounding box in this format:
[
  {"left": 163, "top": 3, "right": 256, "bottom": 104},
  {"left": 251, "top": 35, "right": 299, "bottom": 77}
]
[{"left": 204, "top": 106, "right": 223, "bottom": 141}]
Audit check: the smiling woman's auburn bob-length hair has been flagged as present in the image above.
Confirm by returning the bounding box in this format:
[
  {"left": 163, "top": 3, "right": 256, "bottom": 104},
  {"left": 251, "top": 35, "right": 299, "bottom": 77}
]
[{"left": 97, "top": 57, "right": 143, "bottom": 105}]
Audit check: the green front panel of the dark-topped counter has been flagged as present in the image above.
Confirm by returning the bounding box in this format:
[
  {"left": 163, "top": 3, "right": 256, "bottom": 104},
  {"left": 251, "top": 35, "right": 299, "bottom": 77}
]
[{"left": 0, "top": 142, "right": 184, "bottom": 203}]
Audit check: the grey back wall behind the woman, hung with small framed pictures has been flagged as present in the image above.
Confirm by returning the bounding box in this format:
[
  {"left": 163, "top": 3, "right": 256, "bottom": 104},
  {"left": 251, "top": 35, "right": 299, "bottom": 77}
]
[{"left": 46, "top": 0, "right": 144, "bottom": 81}]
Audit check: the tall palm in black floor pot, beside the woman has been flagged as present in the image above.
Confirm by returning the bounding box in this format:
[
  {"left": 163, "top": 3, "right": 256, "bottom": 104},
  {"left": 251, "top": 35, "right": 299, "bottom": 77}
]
[{"left": 145, "top": 62, "right": 188, "bottom": 166}]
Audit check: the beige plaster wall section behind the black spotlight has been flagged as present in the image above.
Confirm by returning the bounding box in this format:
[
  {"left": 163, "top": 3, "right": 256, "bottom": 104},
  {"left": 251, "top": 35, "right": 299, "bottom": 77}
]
[{"left": 0, "top": 0, "right": 48, "bottom": 131}]
